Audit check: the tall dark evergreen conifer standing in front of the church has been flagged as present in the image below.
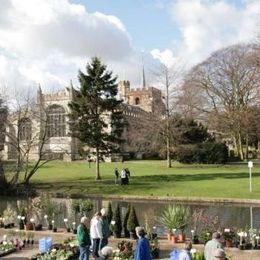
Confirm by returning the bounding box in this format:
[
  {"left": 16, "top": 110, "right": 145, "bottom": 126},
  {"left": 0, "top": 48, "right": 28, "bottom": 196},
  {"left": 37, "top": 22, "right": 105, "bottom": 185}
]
[{"left": 70, "top": 57, "right": 124, "bottom": 180}]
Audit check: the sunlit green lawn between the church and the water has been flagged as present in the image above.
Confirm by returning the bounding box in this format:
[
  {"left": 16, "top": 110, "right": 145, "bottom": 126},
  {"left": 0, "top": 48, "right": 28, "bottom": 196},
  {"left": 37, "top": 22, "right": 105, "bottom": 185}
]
[{"left": 26, "top": 161, "right": 260, "bottom": 200}]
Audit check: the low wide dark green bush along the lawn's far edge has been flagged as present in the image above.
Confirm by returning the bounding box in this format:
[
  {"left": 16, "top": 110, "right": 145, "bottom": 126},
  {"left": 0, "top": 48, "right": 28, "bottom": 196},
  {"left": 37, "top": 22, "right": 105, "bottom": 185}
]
[{"left": 175, "top": 142, "right": 228, "bottom": 164}]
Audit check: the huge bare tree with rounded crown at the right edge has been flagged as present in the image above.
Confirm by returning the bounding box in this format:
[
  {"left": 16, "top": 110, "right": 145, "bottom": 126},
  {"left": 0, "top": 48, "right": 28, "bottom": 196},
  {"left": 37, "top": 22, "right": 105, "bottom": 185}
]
[{"left": 183, "top": 45, "right": 260, "bottom": 159}]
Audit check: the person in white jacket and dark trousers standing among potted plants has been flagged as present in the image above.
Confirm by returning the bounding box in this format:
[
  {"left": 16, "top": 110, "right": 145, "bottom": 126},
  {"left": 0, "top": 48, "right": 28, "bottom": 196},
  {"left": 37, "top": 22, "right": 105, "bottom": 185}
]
[{"left": 90, "top": 212, "right": 103, "bottom": 258}]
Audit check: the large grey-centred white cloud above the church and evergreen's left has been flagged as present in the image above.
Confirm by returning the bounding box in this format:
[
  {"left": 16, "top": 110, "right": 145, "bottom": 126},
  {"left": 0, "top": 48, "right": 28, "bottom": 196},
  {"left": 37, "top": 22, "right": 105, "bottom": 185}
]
[{"left": 0, "top": 0, "right": 140, "bottom": 93}]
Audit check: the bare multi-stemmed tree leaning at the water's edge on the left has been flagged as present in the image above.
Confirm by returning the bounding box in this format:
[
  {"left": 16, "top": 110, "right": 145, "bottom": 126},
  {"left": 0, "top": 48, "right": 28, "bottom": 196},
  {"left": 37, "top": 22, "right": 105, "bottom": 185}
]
[{"left": 2, "top": 90, "right": 65, "bottom": 187}]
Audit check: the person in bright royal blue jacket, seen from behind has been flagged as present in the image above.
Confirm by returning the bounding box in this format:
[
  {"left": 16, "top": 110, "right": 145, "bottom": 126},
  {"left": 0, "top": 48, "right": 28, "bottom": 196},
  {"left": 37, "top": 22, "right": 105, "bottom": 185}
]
[{"left": 135, "top": 227, "right": 152, "bottom": 260}]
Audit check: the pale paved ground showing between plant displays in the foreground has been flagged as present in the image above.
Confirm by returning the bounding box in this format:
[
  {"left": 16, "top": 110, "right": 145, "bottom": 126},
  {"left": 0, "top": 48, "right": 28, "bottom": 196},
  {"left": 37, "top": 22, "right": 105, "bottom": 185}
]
[{"left": 0, "top": 229, "right": 260, "bottom": 260}]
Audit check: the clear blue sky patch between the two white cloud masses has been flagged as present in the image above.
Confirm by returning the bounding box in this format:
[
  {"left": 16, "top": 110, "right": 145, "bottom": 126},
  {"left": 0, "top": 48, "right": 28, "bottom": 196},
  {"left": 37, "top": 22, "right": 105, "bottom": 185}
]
[{"left": 71, "top": 0, "right": 248, "bottom": 50}]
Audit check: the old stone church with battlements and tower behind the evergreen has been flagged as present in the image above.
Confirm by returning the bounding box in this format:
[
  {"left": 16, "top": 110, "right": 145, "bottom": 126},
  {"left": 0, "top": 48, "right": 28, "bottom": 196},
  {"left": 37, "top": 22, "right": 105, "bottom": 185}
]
[{"left": 3, "top": 81, "right": 165, "bottom": 160}]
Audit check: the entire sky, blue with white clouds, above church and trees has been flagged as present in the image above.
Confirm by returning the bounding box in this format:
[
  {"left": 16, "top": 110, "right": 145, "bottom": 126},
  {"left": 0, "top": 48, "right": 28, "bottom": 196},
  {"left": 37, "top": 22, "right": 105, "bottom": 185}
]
[{"left": 0, "top": 0, "right": 260, "bottom": 91}]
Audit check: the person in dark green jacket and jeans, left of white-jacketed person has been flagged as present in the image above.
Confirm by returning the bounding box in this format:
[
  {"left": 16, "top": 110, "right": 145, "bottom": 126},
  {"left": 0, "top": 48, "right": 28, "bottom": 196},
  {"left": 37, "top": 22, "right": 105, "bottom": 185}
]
[{"left": 77, "top": 217, "right": 91, "bottom": 260}]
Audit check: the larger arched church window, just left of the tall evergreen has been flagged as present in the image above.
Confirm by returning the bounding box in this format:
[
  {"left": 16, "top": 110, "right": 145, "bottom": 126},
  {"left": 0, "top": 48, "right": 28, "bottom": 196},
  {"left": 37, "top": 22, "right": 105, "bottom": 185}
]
[{"left": 47, "top": 105, "right": 66, "bottom": 137}]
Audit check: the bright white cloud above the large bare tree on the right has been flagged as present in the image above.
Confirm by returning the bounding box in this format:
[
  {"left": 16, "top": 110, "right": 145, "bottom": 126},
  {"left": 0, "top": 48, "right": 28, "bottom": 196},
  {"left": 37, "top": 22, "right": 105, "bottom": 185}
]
[{"left": 151, "top": 0, "right": 260, "bottom": 68}]
